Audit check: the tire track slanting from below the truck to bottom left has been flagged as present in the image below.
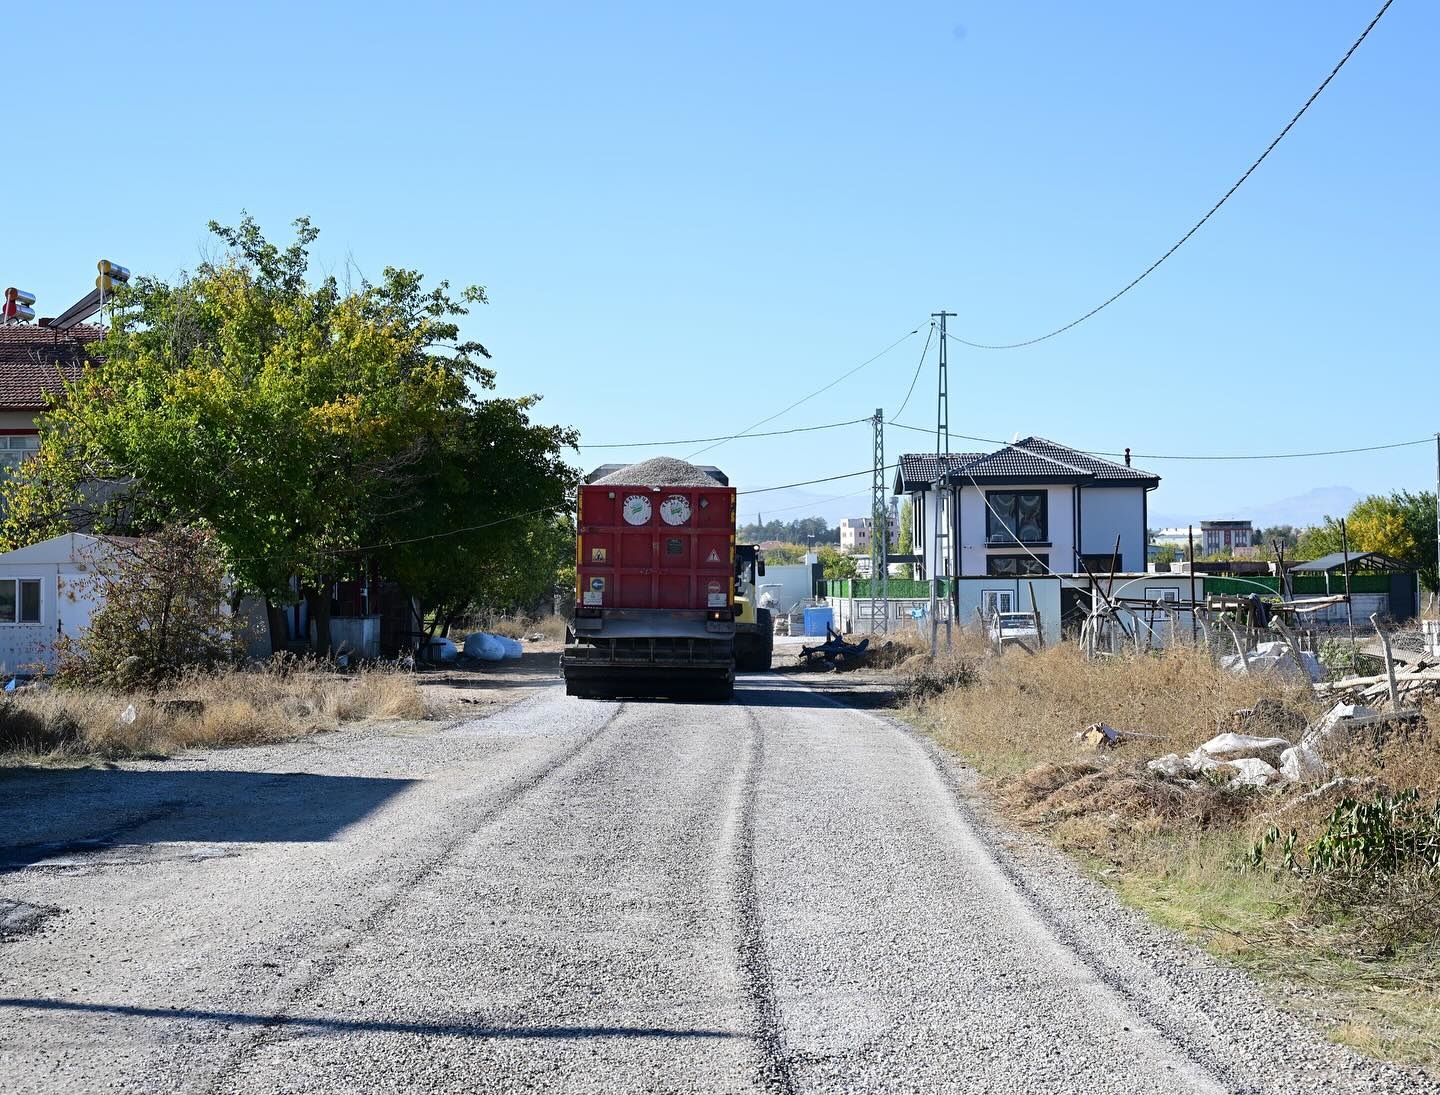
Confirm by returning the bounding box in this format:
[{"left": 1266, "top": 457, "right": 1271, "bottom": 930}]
[{"left": 204, "top": 703, "right": 629, "bottom": 1092}]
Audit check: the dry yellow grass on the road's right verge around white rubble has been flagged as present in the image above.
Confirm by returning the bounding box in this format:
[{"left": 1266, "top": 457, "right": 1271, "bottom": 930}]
[{"left": 912, "top": 647, "right": 1440, "bottom": 1066}]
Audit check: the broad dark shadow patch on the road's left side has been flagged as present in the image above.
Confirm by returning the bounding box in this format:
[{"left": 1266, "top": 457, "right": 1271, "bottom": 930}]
[{"left": 0, "top": 769, "right": 416, "bottom": 873}]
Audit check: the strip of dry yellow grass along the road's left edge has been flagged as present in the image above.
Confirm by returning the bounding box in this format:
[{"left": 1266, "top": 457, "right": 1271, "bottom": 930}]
[{"left": 0, "top": 663, "right": 425, "bottom": 764}]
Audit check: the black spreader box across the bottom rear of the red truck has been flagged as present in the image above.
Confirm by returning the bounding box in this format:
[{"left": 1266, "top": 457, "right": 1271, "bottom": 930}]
[{"left": 560, "top": 638, "right": 734, "bottom": 700}]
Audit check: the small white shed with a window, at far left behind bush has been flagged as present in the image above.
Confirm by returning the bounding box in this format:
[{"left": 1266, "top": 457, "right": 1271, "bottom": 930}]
[{"left": 0, "top": 532, "right": 118, "bottom": 676}]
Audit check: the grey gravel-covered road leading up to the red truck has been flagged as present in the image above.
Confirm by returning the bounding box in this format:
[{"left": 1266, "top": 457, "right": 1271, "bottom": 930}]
[{"left": 0, "top": 674, "right": 1433, "bottom": 1092}]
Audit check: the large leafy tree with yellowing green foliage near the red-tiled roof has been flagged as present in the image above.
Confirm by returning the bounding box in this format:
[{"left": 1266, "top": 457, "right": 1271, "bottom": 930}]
[{"left": 3, "top": 218, "right": 575, "bottom": 653}]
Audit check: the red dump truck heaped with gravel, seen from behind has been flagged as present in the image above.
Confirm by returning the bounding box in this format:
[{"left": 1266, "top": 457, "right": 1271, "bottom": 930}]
[{"left": 560, "top": 457, "right": 736, "bottom": 700}]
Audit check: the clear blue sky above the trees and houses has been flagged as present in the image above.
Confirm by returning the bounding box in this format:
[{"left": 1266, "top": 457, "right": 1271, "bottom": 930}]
[{"left": 0, "top": 0, "right": 1440, "bottom": 527}]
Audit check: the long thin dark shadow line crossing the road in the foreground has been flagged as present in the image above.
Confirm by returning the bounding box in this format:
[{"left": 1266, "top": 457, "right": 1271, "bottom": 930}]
[{"left": 0, "top": 997, "right": 749, "bottom": 1039}]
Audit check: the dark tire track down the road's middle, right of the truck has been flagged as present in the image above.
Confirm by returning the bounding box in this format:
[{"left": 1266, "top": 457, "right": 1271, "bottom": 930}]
[{"left": 732, "top": 707, "right": 796, "bottom": 1095}]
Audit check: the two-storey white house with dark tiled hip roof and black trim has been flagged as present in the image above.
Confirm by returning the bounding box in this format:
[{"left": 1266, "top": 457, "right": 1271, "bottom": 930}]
[{"left": 894, "top": 437, "right": 1159, "bottom": 578}]
